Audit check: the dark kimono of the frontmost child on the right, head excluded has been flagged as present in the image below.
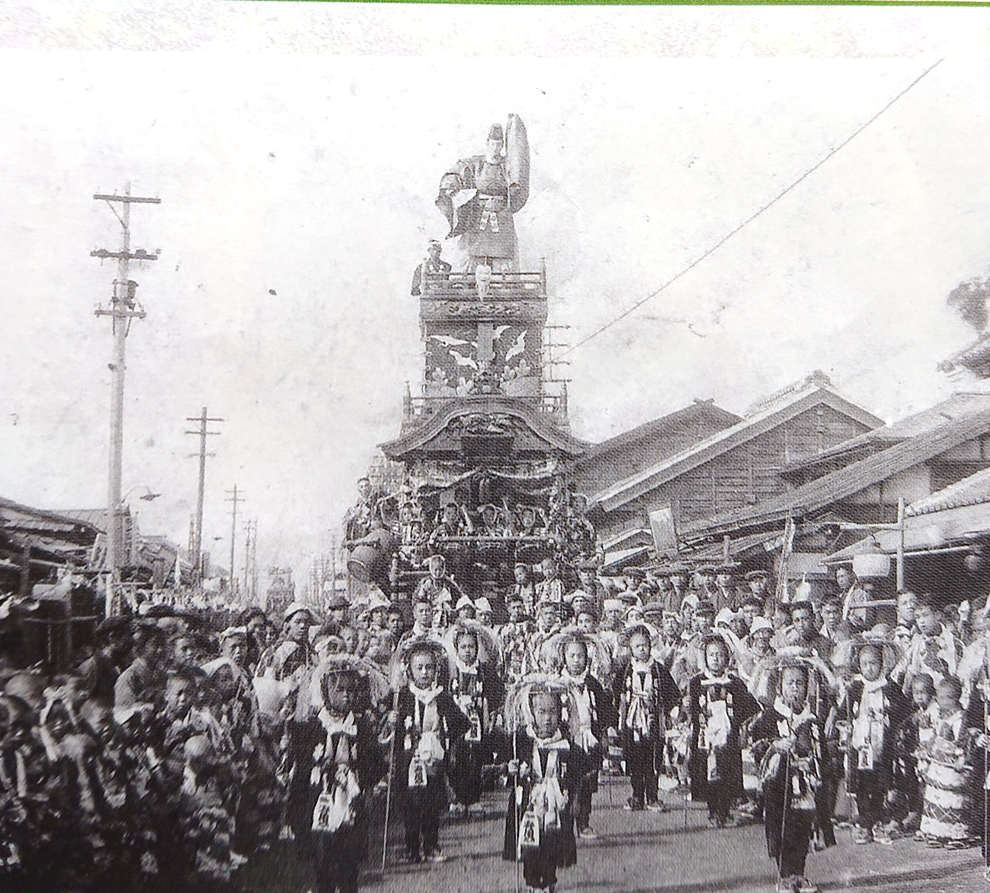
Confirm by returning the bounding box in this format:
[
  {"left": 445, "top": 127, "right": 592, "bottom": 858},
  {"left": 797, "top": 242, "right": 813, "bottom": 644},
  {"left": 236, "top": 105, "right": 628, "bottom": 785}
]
[{"left": 750, "top": 698, "right": 835, "bottom": 878}]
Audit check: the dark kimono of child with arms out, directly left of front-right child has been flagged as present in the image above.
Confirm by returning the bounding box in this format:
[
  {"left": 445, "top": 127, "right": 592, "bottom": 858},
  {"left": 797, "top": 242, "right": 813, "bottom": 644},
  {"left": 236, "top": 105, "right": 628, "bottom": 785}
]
[{"left": 688, "top": 670, "right": 760, "bottom": 826}]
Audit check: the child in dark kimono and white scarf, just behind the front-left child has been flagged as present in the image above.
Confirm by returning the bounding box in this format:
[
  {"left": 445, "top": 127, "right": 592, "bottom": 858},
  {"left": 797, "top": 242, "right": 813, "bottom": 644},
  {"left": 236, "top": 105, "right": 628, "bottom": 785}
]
[{"left": 393, "top": 640, "right": 470, "bottom": 863}]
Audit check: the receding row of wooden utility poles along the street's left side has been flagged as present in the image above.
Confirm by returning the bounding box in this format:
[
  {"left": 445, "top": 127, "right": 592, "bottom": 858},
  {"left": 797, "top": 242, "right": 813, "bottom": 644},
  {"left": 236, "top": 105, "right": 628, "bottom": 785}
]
[{"left": 90, "top": 183, "right": 258, "bottom": 614}]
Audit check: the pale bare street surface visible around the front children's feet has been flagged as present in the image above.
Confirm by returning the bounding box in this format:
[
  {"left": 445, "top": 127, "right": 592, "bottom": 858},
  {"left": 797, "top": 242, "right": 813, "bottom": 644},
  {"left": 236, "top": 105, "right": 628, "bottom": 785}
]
[{"left": 240, "top": 778, "right": 990, "bottom": 893}]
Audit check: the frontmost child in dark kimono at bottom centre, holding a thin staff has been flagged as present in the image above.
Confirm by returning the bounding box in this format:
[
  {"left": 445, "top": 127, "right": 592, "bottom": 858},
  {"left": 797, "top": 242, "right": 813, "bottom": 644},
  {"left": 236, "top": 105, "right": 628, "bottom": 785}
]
[{"left": 502, "top": 683, "right": 588, "bottom": 893}]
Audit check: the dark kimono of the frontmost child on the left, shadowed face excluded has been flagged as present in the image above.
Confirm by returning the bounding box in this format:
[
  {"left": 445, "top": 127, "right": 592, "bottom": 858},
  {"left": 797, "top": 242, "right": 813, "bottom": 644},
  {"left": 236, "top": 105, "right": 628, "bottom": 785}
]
[{"left": 288, "top": 707, "right": 386, "bottom": 893}]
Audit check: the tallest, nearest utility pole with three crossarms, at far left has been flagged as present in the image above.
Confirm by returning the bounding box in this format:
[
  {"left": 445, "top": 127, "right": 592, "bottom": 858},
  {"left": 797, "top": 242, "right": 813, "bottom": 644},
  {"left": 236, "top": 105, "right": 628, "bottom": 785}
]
[{"left": 90, "top": 183, "right": 161, "bottom": 616}]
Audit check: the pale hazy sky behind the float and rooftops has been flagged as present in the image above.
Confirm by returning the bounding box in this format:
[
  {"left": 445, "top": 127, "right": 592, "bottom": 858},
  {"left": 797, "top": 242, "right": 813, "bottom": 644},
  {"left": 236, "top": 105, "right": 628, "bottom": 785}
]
[{"left": 0, "top": 0, "right": 990, "bottom": 585}]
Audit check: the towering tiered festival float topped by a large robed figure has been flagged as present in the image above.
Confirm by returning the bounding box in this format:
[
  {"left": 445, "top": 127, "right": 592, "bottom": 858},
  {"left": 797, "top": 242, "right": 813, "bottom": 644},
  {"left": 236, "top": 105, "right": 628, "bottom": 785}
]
[{"left": 344, "top": 115, "right": 596, "bottom": 616}]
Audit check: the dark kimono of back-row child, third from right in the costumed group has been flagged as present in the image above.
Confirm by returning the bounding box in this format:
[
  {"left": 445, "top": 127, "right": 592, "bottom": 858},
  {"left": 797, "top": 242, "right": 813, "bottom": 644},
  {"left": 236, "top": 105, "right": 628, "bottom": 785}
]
[{"left": 613, "top": 657, "right": 680, "bottom": 809}]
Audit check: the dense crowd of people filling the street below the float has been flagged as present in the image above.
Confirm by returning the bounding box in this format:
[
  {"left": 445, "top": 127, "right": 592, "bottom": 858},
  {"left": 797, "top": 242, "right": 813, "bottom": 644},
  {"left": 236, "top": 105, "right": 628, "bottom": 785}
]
[{"left": 0, "top": 554, "right": 990, "bottom": 893}]
